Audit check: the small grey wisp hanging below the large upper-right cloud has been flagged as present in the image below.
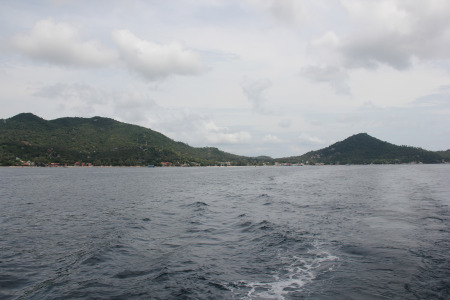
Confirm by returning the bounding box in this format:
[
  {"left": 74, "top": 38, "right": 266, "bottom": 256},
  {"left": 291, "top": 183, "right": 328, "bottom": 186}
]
[{"left": 300, "top": 66, "right": 350, "bottom": 95}]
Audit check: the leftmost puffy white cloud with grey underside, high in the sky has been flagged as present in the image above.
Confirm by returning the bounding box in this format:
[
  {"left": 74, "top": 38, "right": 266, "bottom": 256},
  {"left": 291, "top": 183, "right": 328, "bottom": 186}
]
[{"left": 11, "top": 19, "right": 117, "bottom": 67}]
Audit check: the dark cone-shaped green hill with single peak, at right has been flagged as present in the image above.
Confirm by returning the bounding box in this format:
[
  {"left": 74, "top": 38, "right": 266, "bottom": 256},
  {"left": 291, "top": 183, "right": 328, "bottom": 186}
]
[{"left": 278, "top": 133, "right": 444, "bottom": 164}]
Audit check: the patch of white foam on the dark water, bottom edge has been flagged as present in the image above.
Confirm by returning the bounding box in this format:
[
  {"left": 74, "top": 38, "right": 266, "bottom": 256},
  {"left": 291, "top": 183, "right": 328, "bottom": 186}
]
[{"left": 232, "top": 248, "right": 338, "bottom": 299}]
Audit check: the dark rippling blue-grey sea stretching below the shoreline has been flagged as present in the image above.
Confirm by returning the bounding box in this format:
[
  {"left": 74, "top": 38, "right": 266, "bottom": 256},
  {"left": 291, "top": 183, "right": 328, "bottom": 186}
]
[{"left": 0, "top": 165, "right": 450, "bottom": 299}]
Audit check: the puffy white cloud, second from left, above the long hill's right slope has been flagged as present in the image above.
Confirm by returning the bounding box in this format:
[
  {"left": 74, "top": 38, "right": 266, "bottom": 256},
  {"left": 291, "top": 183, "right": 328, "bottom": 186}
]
[{"left": 112, "top": 30, "right": 205, "bottom": 81}]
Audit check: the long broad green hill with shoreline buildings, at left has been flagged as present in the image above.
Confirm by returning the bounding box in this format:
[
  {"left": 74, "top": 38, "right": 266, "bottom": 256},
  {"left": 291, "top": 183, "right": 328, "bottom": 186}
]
[{"left": 0, "top": 113, "right": 259, "bottom": 166}]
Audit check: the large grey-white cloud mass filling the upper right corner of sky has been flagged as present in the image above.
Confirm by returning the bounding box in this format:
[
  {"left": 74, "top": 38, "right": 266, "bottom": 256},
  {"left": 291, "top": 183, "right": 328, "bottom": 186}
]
[{"left": 301, "top": 0, "right": 450, "bottom": 94}]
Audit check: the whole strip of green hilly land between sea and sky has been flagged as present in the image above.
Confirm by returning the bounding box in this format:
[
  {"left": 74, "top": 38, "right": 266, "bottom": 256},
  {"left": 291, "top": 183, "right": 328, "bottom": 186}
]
[{"left": 0, "top": 113, "right": 450, "bottom": 166}]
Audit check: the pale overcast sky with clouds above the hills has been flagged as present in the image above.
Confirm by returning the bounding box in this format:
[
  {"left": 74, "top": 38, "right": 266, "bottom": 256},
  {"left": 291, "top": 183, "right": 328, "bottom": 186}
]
[{"left": 0, "top": 0, "right": 450, "bottom": 158}]
